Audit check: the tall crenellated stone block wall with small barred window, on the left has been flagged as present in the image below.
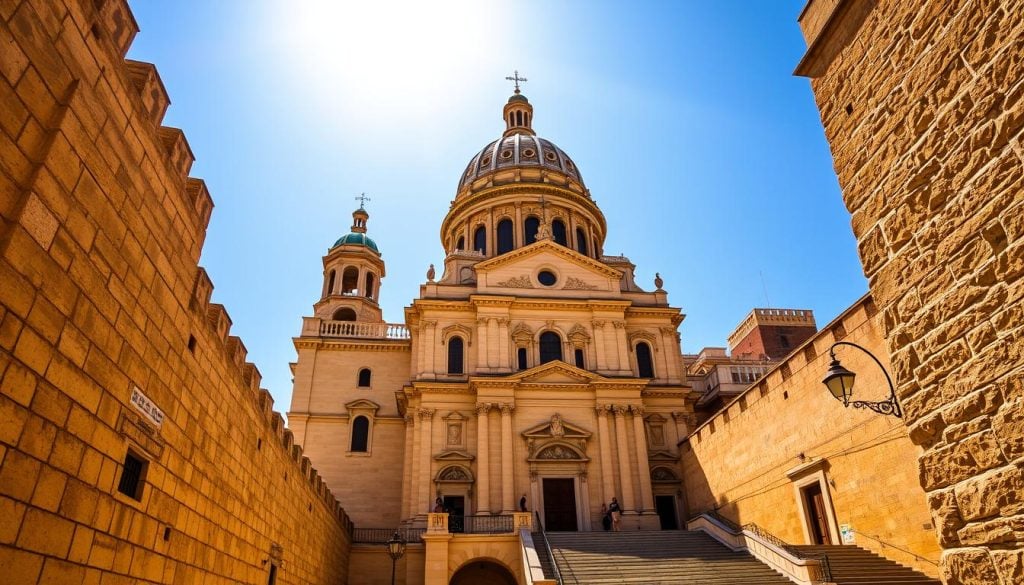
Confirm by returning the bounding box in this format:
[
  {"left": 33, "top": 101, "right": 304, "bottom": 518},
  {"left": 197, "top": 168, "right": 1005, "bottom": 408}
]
[{"left": 0, "top": 0, "right": 350, "bottom": 585}]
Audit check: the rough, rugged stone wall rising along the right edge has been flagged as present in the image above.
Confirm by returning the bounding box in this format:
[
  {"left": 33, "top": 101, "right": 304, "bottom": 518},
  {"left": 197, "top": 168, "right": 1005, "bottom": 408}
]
[{"left": 797, "top": 0, "right": 1024, "bottom": 585}]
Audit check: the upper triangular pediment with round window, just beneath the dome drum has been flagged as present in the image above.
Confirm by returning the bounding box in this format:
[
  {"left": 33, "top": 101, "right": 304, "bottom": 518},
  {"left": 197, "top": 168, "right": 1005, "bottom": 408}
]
[{"left": 474, "top": 240, "right": 623, "bottom": 294}]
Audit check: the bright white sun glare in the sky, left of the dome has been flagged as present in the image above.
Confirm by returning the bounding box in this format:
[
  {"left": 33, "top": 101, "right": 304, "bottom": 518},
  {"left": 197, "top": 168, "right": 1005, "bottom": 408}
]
[{"left": 272, "top": 0, "right": 502, "bottom": 129}]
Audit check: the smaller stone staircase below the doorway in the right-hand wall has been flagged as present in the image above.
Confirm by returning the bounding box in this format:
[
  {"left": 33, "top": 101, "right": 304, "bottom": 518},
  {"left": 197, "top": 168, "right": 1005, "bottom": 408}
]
[{"left": 790, "top": 545, "right": 941, "bottom": 585}]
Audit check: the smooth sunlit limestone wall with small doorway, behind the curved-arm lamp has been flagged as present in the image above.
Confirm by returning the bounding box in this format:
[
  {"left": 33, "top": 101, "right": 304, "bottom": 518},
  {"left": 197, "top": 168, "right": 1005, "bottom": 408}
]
[{"left": 680, "top": 297, "right": 939, "bottom": 575}]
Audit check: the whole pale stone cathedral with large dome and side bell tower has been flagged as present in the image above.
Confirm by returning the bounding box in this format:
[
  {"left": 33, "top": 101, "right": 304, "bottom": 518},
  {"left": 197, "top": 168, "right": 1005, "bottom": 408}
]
[{"left": 288, "top": 89, "right": 696, "bottom": 545}]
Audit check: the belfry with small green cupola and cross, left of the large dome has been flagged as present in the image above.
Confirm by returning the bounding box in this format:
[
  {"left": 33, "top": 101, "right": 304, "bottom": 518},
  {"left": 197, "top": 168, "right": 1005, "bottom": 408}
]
[{"left": 313, "top": 202, "right": 385, "bottom": 323}]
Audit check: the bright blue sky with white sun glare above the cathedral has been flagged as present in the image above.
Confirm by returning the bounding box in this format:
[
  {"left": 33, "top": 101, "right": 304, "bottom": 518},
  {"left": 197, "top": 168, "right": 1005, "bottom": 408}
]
[{"left": 129, "top": 0, "right": 866, "bottom": 411}]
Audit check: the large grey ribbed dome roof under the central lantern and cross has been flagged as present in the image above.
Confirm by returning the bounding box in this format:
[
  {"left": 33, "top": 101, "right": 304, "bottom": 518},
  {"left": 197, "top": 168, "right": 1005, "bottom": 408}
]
[{"left": 459, "top": 133, "right": 583, "bottom": 192}]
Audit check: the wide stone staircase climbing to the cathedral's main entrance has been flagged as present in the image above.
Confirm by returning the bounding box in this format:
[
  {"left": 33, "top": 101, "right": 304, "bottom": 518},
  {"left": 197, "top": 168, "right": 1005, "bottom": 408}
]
[{"left": 542, "top": 531, "right": 790, "bottom": 585}]
